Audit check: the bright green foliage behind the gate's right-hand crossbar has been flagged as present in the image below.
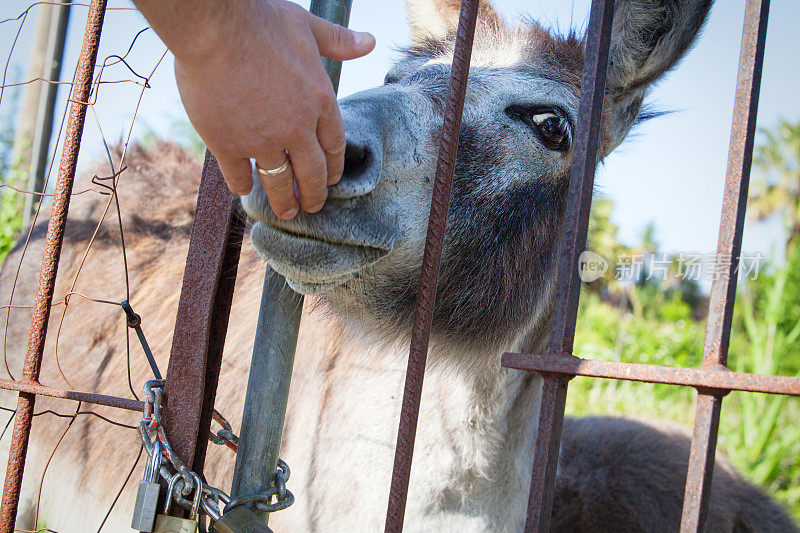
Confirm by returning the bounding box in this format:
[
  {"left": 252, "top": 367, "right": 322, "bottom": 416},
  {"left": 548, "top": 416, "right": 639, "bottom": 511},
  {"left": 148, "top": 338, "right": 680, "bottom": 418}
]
[{"left": 567, "top": 253, "right": 800, "bottom": 520}]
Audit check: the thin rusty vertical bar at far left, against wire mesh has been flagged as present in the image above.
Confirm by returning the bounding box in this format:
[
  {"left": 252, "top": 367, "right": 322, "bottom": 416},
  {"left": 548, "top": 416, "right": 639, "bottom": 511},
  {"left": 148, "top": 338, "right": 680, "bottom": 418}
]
[{"left": 0, "top": 0, "right": 106, "bottom": 532}]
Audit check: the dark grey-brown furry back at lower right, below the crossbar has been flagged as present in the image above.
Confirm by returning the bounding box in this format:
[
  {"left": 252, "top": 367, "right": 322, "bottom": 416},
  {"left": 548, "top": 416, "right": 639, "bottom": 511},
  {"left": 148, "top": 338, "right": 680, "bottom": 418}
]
[{"left": 552, "top": 417, "right": 797, "bottom": 533}]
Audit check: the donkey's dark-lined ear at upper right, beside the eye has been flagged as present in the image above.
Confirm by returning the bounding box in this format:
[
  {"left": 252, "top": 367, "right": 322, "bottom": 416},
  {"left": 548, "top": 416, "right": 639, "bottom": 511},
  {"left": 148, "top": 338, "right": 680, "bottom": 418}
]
[{"left": 602, "top": 0, "right": 713, "bottom": 155}]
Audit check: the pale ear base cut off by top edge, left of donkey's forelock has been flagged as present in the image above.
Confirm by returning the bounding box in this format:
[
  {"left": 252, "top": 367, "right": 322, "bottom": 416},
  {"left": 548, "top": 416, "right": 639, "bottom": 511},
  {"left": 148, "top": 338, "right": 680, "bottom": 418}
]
[{"left": 406, "top": 0, "right": 503, "bottom": 43}]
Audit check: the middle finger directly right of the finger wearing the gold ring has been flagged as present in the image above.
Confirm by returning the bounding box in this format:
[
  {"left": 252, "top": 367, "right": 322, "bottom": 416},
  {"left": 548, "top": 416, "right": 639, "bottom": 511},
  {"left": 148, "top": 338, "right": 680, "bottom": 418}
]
[{"left": 289, "top": 134, "right": 328, "bottom": 213}]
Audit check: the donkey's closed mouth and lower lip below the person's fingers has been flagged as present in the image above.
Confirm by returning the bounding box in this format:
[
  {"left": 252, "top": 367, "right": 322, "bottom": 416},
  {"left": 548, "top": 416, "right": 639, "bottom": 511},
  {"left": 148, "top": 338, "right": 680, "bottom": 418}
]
[{"left": 251, "top": 221, "right": 392, "bottom": 294}]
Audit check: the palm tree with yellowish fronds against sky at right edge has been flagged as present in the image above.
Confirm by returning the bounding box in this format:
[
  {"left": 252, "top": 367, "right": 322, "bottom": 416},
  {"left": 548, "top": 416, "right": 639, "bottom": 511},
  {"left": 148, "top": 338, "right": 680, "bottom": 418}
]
[{"left": 749, "top": 120, "right": 800, "bottom": 250}]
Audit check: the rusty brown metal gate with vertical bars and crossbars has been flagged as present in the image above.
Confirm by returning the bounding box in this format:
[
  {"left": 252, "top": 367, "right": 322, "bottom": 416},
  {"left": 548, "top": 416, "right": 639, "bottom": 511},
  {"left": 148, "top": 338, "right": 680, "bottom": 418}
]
[{"left": 0, "top": 0, "right": 800, "bottom": 532}]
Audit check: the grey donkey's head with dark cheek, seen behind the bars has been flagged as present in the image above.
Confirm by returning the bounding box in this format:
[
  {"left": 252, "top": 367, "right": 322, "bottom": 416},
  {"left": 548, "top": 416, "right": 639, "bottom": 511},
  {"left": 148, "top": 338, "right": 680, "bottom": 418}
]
[{"left": 244, "top": 0, "right": 712, "bottom": 354}]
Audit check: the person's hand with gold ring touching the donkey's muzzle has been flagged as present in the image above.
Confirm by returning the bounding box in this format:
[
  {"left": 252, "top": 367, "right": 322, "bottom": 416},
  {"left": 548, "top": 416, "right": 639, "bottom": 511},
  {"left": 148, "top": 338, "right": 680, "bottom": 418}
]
[{"left": 146, "top": 0, "right": 375, "bottom": 219}]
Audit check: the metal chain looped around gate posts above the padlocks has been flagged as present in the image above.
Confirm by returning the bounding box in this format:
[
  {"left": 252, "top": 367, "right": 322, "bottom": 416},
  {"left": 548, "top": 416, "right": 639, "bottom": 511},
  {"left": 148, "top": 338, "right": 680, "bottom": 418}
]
[{"left": 139, "top": 379, "right": 294, "bottom": 523}]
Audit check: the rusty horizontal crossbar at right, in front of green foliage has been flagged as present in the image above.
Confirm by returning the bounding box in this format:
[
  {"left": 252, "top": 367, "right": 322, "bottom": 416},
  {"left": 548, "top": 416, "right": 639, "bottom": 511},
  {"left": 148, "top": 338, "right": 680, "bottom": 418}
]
[{"left": 502, "top": 353, "right": 800, "bottom": 396}]
